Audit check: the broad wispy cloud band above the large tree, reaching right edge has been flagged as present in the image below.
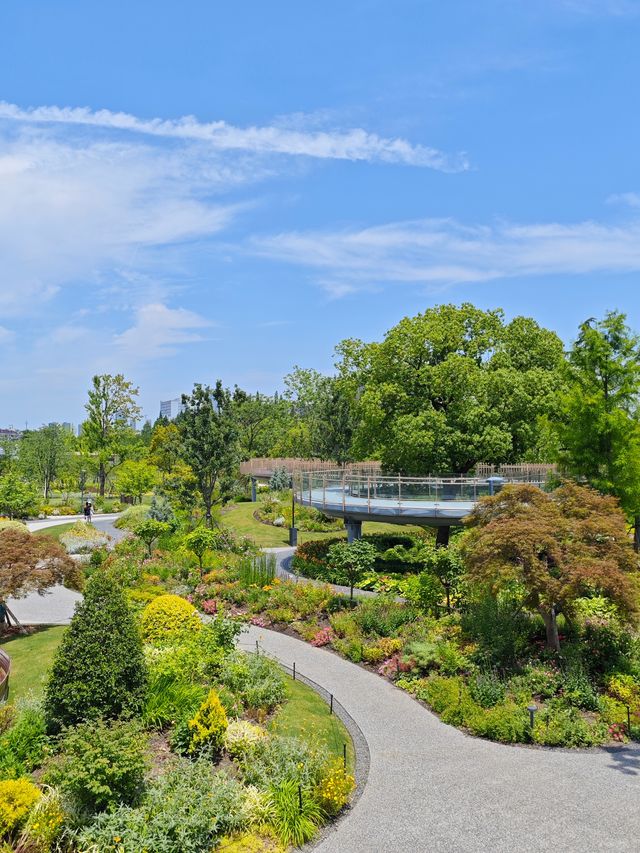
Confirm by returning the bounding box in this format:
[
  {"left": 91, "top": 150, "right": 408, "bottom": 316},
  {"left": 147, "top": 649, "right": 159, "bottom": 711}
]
[{"left": 252, "top": 219, "right": 640, "bottom": 297}]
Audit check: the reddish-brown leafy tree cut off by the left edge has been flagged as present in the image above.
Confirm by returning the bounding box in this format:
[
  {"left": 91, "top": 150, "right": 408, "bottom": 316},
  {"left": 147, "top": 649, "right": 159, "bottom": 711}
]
[{"left": 0, "top": 528, "right": 82, "bottom": 601}]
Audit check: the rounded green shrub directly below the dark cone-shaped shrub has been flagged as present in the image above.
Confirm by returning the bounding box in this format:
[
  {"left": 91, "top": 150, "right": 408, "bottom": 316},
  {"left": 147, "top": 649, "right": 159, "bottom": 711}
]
[{"left": 46, "top": 720, "right": 147, "bottom": 814}]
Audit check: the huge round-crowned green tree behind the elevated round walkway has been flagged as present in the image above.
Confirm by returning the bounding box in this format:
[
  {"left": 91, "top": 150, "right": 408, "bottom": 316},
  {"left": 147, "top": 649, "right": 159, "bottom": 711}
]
[{"left": 338, "top": 303, "right": 563, "bottom": 475}]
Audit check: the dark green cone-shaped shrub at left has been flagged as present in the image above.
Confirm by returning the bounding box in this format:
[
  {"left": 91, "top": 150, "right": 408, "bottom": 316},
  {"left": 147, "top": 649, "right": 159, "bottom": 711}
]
[{"left": 44, "top": 571, "right": 146, "bottom": 731}]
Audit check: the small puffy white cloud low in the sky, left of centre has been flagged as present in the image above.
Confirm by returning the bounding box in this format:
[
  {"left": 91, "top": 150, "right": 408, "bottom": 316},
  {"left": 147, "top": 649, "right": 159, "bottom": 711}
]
[{"left": 115, "top": 303, "right": 213, "bottom": 361}]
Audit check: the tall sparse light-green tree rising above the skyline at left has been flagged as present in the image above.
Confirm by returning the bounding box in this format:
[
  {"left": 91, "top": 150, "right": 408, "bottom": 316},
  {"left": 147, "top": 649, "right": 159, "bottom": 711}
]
[{"left": 82, "top": 373, "right": 140, "bottom": 497}]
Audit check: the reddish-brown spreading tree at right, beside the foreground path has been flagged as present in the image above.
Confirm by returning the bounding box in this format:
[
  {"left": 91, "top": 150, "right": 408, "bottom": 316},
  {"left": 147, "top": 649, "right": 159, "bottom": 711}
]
[{"left": 462, "top": 483, "right": 638, "bottom": 650}]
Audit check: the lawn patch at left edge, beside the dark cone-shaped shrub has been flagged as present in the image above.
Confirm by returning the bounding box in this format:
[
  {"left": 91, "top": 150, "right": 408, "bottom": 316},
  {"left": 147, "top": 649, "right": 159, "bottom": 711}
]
[{"left": 0, "top": 625, "right": 66, "bottom": 702}]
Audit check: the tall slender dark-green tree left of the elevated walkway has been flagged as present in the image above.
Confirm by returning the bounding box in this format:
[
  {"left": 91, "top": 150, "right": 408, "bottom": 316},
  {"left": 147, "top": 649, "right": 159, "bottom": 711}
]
[{"left": 177, "top": 381, "right": 239, "bottom": 527}]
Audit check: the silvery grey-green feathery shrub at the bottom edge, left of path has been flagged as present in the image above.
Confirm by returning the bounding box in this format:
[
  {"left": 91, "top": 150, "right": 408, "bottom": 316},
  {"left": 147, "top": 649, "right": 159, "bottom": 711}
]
[{"left": 77, "top": 759, "right": 249, "bottom": 853}]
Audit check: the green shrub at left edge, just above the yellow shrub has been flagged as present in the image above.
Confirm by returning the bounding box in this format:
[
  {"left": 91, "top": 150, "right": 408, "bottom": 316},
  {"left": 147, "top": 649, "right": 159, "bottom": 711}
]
[{"left": 0, "top": 703, "right": 49, "bottom": 779}]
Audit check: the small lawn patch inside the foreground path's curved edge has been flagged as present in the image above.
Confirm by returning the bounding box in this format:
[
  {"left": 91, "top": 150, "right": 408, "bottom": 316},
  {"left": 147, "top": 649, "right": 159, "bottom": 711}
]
[{"left": 269, "top": 676, "right": 355, "bottom": 772}]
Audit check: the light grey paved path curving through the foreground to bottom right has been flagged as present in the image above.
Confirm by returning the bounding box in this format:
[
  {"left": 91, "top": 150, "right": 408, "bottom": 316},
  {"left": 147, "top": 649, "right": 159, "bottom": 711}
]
[{"left": 240, "top": 626, "right": 640, "bottom": 853}]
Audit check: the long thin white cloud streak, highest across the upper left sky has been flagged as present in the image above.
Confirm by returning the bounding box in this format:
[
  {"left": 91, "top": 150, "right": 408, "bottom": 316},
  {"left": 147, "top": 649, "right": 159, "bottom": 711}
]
[{"left": 0, "top": 102, "right": 468, "bottom": 172}]
